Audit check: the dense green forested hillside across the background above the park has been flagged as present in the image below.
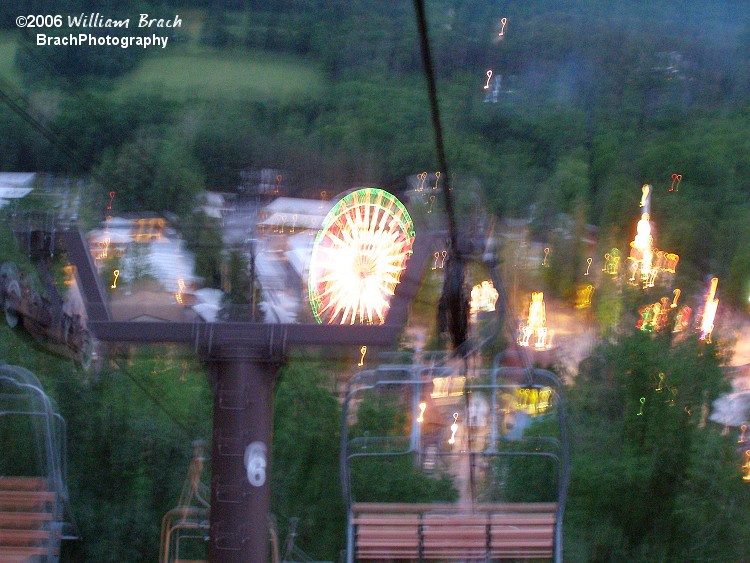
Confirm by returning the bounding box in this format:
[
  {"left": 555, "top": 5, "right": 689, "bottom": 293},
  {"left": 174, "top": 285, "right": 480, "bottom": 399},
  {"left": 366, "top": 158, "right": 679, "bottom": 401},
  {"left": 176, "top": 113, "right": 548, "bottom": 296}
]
[{"left": 0, "top": 0, "right": 750, "bottom": 304}]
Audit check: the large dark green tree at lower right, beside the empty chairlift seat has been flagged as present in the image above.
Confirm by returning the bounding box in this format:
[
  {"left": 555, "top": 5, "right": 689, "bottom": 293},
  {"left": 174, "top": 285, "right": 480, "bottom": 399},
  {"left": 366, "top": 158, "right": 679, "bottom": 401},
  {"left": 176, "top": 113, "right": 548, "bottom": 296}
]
[{"left": 566, "top": 331, "right": 747, "bottom": 560}]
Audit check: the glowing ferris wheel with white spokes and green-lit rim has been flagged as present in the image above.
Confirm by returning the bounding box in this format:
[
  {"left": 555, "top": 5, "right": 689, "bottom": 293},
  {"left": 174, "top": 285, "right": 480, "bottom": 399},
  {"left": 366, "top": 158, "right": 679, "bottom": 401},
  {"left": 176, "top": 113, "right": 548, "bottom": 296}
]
[{"left": 308, "top": 188, "right": 414, "bottom": 324}]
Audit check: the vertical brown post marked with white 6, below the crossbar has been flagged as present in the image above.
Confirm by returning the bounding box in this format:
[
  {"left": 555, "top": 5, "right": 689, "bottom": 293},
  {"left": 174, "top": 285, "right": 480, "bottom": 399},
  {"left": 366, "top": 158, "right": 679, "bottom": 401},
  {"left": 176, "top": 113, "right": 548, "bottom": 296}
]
[{"left": 208, "top": 346, "right": 281, "bottom": 563}]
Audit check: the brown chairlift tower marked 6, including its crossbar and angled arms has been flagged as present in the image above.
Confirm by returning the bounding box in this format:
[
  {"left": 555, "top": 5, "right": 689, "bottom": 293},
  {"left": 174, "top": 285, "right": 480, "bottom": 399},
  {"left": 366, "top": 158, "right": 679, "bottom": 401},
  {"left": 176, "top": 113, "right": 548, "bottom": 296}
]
[{"left": 62, "top": 227, "right": 433, "bottom": 563}]
